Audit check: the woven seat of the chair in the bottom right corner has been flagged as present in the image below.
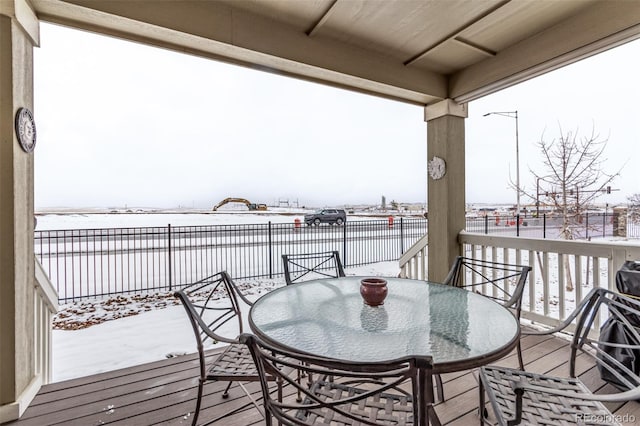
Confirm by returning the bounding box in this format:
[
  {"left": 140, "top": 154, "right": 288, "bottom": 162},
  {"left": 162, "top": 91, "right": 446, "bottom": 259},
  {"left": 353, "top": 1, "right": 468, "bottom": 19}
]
[{"left": 480, "top": 366, "right": 619, "bottom": 425}]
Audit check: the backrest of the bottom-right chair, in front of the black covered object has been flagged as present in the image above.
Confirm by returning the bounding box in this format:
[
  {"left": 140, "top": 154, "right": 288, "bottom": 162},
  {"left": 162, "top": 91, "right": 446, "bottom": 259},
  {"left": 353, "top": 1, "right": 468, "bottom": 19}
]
[{"left": 556, "top": 288, "right": 640, "bottom": 391}]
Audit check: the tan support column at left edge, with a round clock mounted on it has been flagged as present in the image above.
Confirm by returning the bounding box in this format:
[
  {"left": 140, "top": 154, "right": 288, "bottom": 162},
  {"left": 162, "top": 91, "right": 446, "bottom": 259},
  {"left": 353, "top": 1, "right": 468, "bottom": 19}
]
[{"left": 0, "top": 0, "right": 41, "bottom": 423}]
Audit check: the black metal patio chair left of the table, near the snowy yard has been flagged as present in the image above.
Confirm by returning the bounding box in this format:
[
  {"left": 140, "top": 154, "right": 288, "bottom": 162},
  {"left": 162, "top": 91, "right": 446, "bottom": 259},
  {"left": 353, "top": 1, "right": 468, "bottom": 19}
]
[{"left": 174, "top": 271, "right": 281, "bottom": 426}]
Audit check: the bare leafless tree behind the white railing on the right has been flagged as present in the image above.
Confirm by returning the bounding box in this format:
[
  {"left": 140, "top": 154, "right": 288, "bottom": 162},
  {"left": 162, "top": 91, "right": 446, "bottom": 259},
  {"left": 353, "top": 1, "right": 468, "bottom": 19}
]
[{"left": 525, "top": 127, "right": 620, "bottom": 291}]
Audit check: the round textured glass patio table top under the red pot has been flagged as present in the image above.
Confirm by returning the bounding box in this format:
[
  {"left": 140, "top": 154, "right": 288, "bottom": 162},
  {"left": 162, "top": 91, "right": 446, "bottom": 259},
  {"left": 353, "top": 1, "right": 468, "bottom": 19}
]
[{"left": 249, "top": 277, "right": 520, "bottom": 373}]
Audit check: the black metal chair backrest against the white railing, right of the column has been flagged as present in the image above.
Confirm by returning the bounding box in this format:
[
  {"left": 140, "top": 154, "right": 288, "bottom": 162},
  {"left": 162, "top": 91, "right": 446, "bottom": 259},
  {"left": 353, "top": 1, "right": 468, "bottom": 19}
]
[{"left": 444, "top": 256, "right": 531, "bottom": 318}]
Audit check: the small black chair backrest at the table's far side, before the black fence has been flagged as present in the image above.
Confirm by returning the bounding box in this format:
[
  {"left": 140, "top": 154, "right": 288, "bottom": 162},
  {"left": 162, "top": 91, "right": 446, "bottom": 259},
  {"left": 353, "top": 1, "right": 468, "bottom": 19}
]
[{"left": 282, "top": 251, "right": 345, "bottom": 285}]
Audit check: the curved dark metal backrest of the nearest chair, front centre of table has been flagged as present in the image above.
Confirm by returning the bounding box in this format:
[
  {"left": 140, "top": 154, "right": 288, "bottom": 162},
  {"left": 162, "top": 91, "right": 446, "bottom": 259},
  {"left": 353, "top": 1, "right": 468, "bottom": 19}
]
[{"left": 240, "top": 334, "right": 433, "bottom": 426}]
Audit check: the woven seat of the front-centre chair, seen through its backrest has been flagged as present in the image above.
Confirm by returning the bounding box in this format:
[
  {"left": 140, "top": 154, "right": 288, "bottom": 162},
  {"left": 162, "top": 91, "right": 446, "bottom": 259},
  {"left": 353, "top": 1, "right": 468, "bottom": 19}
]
[{"left": 296, "top": 380, "right": 413, "bottom": 426}]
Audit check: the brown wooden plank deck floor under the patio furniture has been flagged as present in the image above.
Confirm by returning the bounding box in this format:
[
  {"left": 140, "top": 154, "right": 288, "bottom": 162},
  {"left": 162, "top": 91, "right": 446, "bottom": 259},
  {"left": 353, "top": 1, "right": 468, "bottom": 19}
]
[{"left": 9, "top": 330, "right": 640, "bottom": 426}]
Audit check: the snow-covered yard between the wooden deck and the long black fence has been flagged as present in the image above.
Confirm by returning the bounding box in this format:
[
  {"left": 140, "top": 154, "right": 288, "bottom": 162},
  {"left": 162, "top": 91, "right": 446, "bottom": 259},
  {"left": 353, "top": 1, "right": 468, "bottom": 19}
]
[{"left": 53, "top": 256, "right": 400, "bottom": 381}]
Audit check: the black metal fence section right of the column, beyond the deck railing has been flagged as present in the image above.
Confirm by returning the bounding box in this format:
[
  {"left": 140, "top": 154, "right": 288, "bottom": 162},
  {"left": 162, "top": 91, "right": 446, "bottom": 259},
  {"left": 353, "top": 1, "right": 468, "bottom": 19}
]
[{"left": 466, "top": 213, "right": 614, "bottom": 239}]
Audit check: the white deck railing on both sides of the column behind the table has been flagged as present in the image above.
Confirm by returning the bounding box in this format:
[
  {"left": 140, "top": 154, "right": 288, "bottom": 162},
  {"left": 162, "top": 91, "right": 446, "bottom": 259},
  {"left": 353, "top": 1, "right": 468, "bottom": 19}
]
[{"left": 399, "top": 231, "right": 640, "bottom": 325}]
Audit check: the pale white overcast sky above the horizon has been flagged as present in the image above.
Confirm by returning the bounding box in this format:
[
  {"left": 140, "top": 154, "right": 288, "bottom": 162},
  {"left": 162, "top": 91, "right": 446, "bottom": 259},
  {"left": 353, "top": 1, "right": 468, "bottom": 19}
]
[{"left": 34, "top": 24, "right": 640, "bottom": 209}]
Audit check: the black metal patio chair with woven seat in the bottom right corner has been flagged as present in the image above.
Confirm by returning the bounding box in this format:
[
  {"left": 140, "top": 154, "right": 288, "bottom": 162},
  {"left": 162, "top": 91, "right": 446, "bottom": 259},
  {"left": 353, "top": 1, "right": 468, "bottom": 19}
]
[{"left": 480, "top": 288, "right": 640, "bottom": 426}]
